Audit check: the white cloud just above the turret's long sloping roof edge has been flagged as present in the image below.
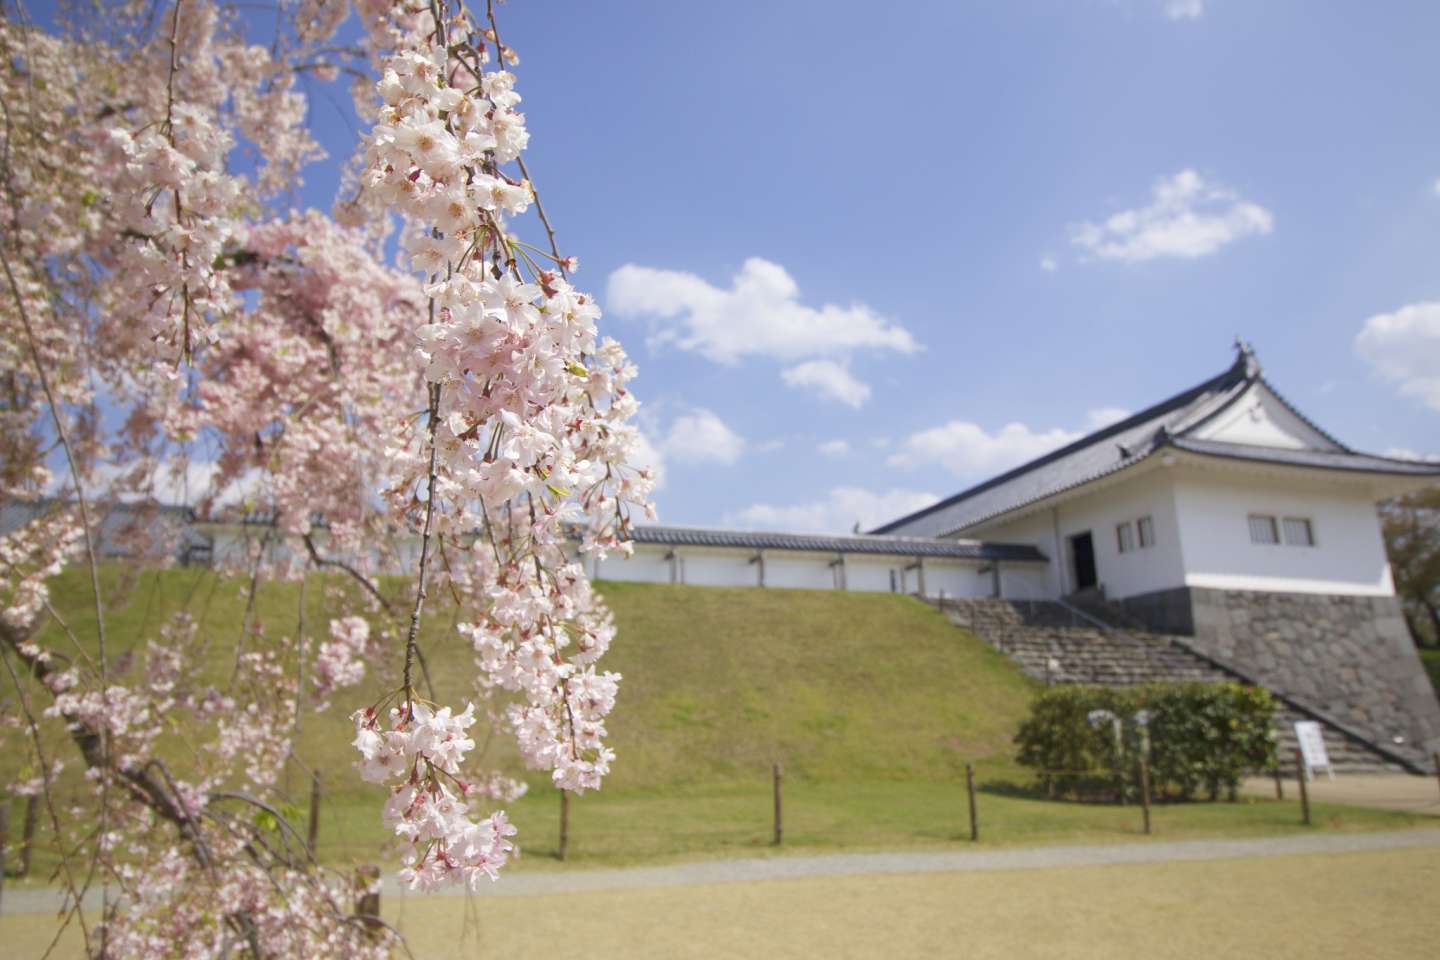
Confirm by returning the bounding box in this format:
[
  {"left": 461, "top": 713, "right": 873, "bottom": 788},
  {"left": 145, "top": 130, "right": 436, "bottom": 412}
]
[{"left": 886, "top": 407, "right": 1129, "bottom": 479}]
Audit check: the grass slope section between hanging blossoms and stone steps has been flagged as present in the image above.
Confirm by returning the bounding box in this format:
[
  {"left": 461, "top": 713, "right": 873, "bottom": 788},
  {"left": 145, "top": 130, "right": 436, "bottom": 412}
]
[{"left": 599, "top": 583, "right": 1031, "bottom": 789}]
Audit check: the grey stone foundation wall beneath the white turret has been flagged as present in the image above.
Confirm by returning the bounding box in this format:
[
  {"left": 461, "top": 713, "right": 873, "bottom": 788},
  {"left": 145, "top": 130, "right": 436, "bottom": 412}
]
[{"left": 1122, "top": 587, "right": 1440, "bottom": 769}]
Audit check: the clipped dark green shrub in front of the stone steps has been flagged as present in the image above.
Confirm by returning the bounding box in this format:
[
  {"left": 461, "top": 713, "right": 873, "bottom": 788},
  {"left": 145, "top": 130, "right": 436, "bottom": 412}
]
[{"left": 1015, "top": 684, "right": 1274, "bottom": 800}]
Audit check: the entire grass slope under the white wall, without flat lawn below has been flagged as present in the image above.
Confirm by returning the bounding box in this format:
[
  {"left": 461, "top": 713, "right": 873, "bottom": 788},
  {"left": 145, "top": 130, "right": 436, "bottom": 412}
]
[{"left": 16, "top": 566, "right": 1031, "bottom": 790}]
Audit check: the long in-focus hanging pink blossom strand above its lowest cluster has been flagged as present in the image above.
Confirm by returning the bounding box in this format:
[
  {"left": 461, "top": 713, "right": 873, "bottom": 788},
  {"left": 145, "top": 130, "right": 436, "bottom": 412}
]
[{"left": 342, "top": 1, "right": 652, "bottom": 886}]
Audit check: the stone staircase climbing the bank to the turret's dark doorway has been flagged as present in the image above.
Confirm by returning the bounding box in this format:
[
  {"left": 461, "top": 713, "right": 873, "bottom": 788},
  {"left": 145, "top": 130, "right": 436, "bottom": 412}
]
[{"left": 930, "top": 599, "right": 1403, "bottom": 773}]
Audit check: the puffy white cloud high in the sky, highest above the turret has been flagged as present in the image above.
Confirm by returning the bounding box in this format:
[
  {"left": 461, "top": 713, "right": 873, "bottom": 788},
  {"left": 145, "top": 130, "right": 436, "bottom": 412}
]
[{"left": 1070, "top": 170, "right": 1274, "bottom": 263}]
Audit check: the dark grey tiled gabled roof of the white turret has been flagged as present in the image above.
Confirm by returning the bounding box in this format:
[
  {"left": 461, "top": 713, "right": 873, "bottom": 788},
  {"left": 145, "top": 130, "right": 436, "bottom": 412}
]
[{"left": 871, "top": 348, "right": 1440, "bottom": 537}]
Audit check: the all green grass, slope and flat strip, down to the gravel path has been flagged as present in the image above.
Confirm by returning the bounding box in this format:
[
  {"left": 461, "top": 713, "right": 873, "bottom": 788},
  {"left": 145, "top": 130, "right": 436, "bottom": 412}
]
[{"left": 8, "top": 567, "right": 1418, "bottom": 874}]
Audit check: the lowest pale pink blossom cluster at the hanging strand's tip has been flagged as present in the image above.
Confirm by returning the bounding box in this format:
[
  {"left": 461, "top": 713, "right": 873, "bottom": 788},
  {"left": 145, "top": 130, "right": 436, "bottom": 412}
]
[{"left": 351, "top": 702, "right": 516, "bottom": 889}]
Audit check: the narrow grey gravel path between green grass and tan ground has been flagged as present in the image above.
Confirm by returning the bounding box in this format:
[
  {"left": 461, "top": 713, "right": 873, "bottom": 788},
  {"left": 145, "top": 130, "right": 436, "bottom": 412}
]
[{"left": 3, "top": 829, "right": 1440, "bottom": 914}]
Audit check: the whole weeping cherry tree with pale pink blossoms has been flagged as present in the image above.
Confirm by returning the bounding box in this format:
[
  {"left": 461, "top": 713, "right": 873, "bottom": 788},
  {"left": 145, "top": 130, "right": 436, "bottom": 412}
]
[{"left": 0, "top": 0, "right": 651, "bottom": 957}]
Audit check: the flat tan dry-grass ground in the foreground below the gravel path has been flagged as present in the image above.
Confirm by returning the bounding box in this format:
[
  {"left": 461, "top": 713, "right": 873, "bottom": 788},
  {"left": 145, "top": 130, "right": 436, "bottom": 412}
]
[{"left": 0, "top": 849, "right": 1440, "bottom": 960}]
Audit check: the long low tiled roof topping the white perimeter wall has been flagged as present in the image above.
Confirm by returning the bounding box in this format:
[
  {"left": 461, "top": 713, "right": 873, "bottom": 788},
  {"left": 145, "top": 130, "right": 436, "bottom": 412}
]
[{"left": 632, "top": 527, "right": 1045, "bottom": 563}]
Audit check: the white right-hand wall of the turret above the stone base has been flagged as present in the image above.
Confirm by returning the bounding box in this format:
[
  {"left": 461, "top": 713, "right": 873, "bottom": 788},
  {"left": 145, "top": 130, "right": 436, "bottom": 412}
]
[{"left": 1175, "top": 469, "right": 1395, "bottom": 596}]
